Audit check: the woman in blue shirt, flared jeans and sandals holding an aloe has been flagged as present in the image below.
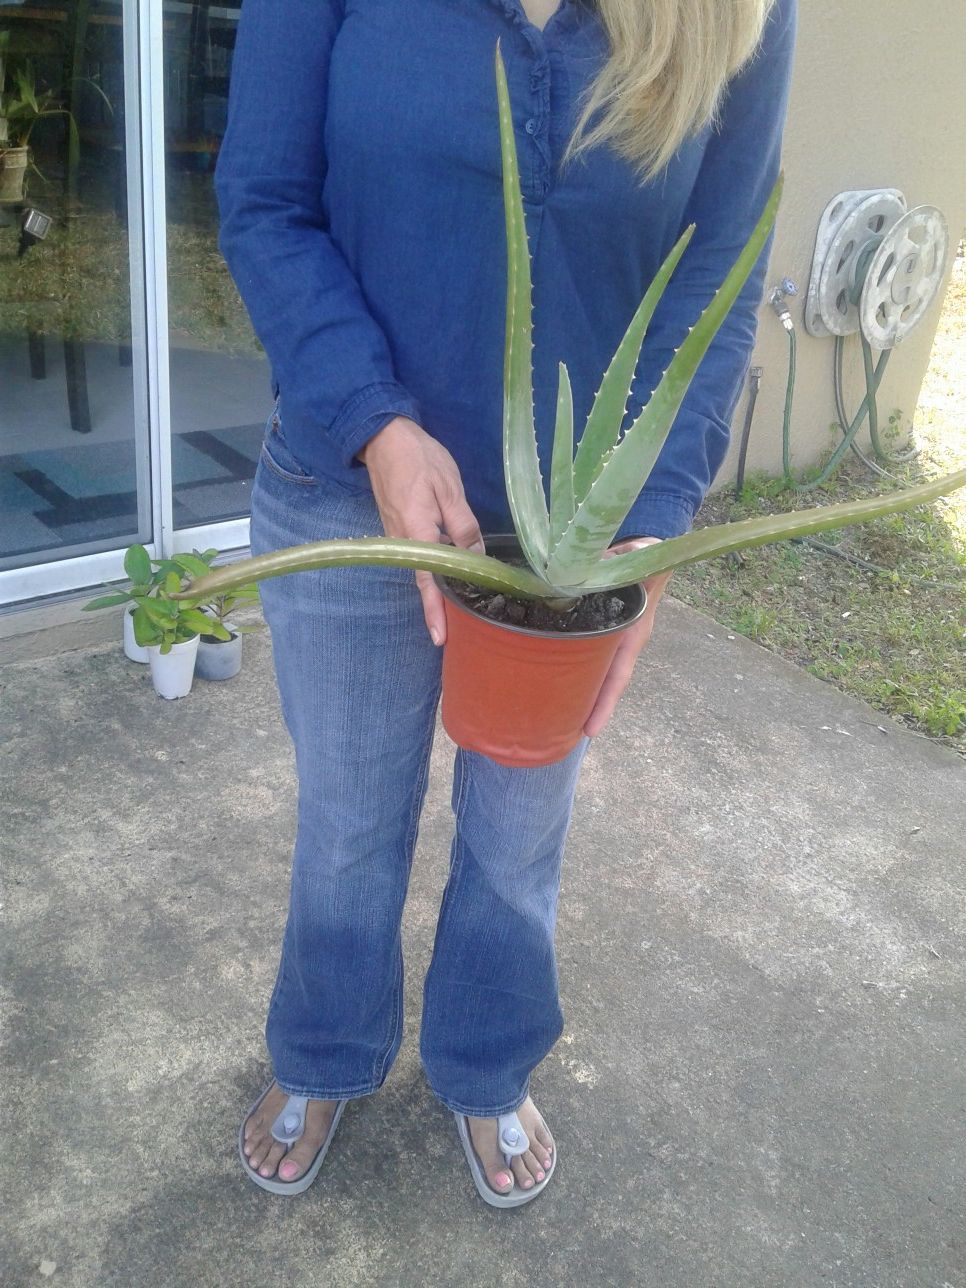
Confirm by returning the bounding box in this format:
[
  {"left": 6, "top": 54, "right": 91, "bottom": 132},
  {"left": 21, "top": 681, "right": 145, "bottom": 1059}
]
[{"left": 218, "top": 0, "right": 795, "bottom": 1207}]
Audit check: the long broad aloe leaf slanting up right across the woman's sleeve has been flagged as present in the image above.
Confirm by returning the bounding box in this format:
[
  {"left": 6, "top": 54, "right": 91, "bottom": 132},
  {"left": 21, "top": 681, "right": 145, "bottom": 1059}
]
[{"left": 546, "top": 178, "right": 782, "bottom": 586}]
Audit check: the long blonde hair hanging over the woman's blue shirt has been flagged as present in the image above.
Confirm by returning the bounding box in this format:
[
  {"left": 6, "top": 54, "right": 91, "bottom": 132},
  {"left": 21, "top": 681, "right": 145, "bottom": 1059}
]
[{"left": 564, "top": 0, "right": 774, "bottom": 178}]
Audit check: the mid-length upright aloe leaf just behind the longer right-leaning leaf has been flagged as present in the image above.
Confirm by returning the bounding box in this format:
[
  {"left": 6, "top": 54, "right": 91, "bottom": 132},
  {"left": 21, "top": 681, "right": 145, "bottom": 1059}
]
[{"left": 573, "top": 224, "right": 694, "bottom": 501}]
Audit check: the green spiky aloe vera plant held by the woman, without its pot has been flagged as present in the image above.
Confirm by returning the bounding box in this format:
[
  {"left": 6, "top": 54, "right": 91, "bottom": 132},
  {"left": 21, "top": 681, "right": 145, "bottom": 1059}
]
[{"left": 187, "top": 48, "right": 966, "bottom": 604}]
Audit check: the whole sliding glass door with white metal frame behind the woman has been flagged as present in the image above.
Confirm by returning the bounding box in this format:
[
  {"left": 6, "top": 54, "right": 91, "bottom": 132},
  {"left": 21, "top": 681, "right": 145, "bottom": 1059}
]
[{"left": 0, "top": 0, "right": 269, "bottom": 604}]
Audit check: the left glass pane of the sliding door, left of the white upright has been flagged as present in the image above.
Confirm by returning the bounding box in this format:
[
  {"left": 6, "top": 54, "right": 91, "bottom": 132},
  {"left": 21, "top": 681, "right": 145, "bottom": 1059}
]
[{"left": 0, "top": 0, "right": 152, "bottom": 581}]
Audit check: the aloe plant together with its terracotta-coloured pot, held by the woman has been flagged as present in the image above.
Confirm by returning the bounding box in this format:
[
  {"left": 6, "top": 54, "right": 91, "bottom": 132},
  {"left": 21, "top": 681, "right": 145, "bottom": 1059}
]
[{"left": 184, "top": 49, "right": 966, "bottom": 765}]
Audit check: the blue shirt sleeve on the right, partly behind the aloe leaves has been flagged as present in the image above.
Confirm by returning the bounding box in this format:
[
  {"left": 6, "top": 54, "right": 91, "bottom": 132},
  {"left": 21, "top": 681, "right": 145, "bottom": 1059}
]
[{"left": 621, "top": 0, "right": 796, "bottom": 538}]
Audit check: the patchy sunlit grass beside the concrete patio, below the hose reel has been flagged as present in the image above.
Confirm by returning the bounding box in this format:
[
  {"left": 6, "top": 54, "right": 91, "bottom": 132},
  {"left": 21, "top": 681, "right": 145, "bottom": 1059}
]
[{"left": 672, "top": 255, "right": 966, "bottom": 756}]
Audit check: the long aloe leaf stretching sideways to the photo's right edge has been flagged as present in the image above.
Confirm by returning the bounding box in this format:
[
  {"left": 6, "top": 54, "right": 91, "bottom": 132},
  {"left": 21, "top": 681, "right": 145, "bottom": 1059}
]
[{"left": 566, "top": 470, "right": 966, "bottom": 591}]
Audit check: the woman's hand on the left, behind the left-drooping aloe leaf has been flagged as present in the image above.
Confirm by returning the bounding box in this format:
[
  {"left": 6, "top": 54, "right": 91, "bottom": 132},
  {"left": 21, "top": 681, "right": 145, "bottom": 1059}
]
[{"left": 358, "top": 416, "right": 484, "bottom": 644}]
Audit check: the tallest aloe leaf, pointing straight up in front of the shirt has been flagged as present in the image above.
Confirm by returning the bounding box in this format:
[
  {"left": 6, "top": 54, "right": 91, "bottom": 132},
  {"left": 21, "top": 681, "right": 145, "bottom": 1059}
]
[{"left": 496, "top": 44, "right": 550, "bottom": 573}]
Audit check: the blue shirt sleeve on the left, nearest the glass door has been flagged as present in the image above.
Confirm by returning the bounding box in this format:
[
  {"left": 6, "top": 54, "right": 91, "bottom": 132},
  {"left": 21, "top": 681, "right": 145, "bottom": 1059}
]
[{"left": 215, "top": 0, "right": 420, "bottom": 468}]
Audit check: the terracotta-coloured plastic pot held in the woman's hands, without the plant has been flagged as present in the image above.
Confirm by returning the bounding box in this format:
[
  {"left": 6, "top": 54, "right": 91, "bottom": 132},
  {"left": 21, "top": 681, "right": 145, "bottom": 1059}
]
[{"left": 439, "top": 536, "right": 645, "bottom": 768}]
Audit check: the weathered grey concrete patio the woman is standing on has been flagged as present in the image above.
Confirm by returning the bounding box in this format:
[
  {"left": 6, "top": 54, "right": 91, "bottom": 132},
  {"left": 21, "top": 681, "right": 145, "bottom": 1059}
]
[{"left": 0, "top": 603, "right": 966, "bottom": 1288}]
